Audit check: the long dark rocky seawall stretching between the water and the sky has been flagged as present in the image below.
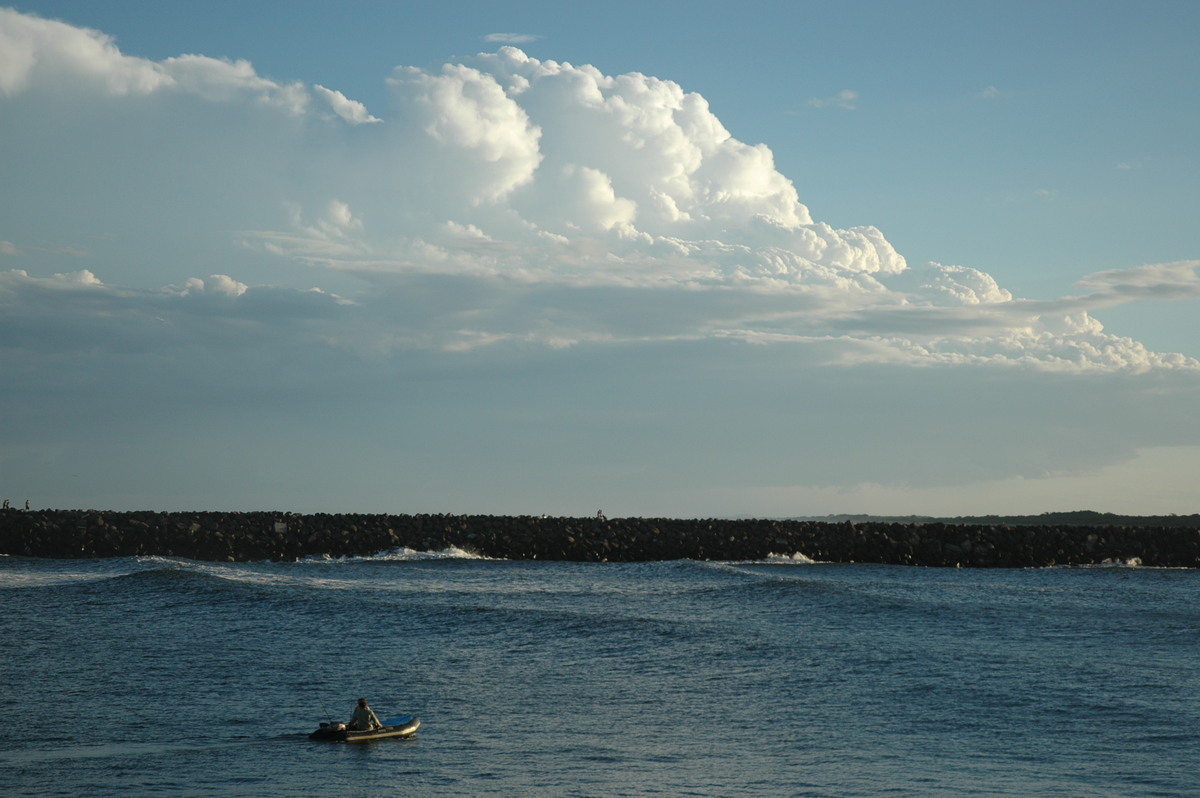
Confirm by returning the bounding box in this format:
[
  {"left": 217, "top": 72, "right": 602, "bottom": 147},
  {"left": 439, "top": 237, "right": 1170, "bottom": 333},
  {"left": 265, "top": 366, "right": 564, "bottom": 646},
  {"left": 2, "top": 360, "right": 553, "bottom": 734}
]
[{"left": 0, "top": 510, "right": 1200, "bottom": 568}]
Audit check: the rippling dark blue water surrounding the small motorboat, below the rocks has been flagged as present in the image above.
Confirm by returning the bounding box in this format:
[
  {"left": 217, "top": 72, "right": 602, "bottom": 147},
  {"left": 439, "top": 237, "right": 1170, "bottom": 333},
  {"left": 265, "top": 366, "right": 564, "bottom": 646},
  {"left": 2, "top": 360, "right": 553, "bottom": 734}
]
[{"left": 0, "top": 553, "right": 1200, "bottom": 797}]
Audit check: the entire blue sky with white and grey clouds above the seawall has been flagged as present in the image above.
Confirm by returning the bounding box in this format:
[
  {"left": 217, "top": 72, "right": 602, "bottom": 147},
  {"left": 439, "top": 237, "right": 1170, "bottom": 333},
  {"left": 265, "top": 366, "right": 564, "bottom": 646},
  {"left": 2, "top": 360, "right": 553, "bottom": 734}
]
[{"left": 0, "top": 0, "right": 1200, "bottom": 517}]
